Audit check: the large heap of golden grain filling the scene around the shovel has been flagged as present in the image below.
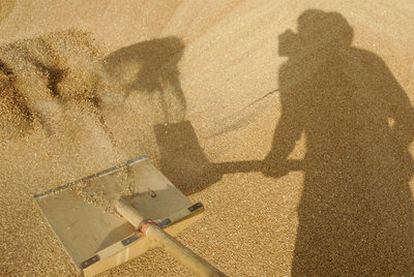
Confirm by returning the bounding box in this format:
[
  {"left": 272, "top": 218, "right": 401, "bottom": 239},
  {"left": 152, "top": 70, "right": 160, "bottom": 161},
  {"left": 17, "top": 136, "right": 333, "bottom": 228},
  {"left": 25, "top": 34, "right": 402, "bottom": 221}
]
[{"left": 0, "top": 0, "right": 414, "bottom": 276}]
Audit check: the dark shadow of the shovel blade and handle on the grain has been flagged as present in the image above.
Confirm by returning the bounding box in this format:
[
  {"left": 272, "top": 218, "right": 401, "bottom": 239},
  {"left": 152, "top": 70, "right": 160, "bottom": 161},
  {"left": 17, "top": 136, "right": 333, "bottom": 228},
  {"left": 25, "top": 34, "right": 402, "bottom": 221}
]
[{"left": 154, "top": 121, "right": 302, "bottom": 195}]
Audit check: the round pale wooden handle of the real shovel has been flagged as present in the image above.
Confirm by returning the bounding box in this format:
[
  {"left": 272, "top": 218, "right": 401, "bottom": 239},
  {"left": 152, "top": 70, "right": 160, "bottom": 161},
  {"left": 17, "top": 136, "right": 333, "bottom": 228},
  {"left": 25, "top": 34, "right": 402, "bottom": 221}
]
[{"left": 115, "top": 200, "right": 226, "bottom": 277}]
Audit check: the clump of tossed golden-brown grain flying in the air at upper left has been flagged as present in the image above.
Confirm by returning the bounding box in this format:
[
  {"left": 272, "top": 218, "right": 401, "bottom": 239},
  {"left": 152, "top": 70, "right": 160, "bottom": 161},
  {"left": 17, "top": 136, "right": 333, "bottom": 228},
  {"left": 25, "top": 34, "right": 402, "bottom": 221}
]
[{"left": 0, "top": 30, "right": 112, "bottom": 138}]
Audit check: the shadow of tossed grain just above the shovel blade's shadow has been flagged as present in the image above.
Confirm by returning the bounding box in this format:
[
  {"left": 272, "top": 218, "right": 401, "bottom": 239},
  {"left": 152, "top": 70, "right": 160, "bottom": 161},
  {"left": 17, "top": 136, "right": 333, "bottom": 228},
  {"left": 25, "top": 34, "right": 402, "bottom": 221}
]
[{"left": 103, "top": 37, "right": 186, "bottom": 122}]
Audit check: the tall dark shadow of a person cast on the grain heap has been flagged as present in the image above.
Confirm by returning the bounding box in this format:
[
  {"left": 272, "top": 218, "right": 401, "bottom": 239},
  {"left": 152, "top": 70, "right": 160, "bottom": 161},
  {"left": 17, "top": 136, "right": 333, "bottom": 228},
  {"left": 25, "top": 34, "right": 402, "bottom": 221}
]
[{"left": 264, "top": 10, "right": 414, "bottom": 276}]
